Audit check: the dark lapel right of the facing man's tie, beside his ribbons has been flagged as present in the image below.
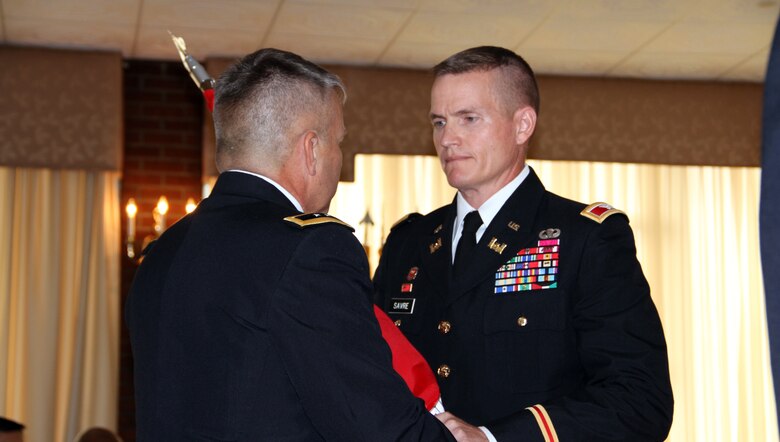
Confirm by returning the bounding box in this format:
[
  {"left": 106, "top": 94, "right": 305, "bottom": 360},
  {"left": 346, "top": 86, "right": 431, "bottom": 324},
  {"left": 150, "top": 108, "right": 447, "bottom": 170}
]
[{"left": 447, "top": 169, "right": 544, "bottom": 304}]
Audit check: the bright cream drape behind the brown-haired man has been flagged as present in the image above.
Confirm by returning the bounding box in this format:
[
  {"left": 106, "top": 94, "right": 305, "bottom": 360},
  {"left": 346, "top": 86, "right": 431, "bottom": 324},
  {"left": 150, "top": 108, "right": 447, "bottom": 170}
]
[{"left": 330, "top": 155, "right": 778, "bottom": 442}]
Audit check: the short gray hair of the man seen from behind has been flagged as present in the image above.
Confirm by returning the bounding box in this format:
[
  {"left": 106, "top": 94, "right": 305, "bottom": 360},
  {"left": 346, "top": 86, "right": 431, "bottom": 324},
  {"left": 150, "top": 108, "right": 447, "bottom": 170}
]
[{"left": 214, "top": 48, "right": 347, "bottom": 171}]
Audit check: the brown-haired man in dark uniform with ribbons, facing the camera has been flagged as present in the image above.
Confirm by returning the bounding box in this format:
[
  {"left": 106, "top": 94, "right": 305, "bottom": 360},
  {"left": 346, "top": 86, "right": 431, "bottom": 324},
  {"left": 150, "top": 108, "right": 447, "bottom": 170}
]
[{"left": 374, "top": 47, "right": 673, "bottom": 442}]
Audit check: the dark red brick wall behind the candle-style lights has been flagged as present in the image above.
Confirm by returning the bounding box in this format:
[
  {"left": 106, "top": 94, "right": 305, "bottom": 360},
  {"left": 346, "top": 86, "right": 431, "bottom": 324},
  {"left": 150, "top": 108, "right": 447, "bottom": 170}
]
[{"left": 118, "top": 60, "right": 205, "bottom": 442}]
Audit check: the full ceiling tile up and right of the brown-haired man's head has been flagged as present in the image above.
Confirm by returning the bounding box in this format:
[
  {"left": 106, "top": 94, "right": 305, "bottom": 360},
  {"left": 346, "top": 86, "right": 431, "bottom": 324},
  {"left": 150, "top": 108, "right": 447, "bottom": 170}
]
[{"left": 523, "top": 17, "right": 665, "bottom": 52}]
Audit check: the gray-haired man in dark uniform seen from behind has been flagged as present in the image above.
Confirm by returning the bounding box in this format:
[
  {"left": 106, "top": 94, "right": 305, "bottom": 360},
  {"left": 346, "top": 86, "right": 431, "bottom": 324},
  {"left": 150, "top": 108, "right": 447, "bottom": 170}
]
[{"left": 126, "top": 49, "right": 451, "bottom": 442}]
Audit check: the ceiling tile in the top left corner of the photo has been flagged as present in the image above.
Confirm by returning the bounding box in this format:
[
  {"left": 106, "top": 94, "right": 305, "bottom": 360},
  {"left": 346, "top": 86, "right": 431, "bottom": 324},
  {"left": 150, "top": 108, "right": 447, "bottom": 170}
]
[{"left": 2, "top": 0, "right": 140, "bottom": 23}]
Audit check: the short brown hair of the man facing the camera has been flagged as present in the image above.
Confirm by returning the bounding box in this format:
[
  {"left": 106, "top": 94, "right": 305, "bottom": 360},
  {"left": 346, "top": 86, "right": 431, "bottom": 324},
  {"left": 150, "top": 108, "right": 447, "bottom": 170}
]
[{"left": 433, "top": 46, "right": 539, "bottom": 114}]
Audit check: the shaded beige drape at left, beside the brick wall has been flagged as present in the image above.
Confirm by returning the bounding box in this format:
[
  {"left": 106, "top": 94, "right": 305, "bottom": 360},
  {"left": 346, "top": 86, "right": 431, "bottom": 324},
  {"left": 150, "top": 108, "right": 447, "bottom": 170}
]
[{"left": 0, "top": 167, "right": 121, "bottom": 442}]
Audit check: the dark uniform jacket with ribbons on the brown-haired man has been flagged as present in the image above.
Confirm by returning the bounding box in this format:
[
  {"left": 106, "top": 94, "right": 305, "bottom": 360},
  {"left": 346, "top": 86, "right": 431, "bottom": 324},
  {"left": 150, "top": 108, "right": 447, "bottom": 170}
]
[{"left": 374, "top": 170, "right": 673, "bottom": 442}]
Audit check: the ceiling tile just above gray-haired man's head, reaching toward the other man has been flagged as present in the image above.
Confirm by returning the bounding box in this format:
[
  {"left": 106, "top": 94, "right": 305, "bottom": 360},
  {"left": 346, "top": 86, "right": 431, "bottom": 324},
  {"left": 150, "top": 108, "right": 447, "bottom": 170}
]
[{"left": 264, "top": 33, "right": 386, "bottom": 65}]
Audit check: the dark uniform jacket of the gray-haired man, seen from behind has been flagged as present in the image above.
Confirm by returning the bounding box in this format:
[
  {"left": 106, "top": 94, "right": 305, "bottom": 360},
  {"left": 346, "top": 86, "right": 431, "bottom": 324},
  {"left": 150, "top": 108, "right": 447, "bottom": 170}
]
[{"left": 126, "top": 172, "right": 451, "bottom": 442}]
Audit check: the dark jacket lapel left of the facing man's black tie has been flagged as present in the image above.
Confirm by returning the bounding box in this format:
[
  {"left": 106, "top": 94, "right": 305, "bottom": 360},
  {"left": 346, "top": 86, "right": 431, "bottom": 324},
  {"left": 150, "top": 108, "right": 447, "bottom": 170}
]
[{"left": 420, "top": 202, "right": 456, "bottom": 296}]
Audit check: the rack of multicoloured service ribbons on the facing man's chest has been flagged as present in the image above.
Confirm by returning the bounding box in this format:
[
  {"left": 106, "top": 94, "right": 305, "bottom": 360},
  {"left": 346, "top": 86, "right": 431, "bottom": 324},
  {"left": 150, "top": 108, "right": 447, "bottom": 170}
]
[{"left": 493, "top": 239, "right": 561, "bottom": 294}]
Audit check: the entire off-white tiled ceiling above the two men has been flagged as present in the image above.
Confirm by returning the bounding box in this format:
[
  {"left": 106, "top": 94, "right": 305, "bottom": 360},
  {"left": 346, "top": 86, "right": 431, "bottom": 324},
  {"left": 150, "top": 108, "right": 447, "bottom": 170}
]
[{"left": 0, "top": 0, "right": 780, "bottom": 81}]
